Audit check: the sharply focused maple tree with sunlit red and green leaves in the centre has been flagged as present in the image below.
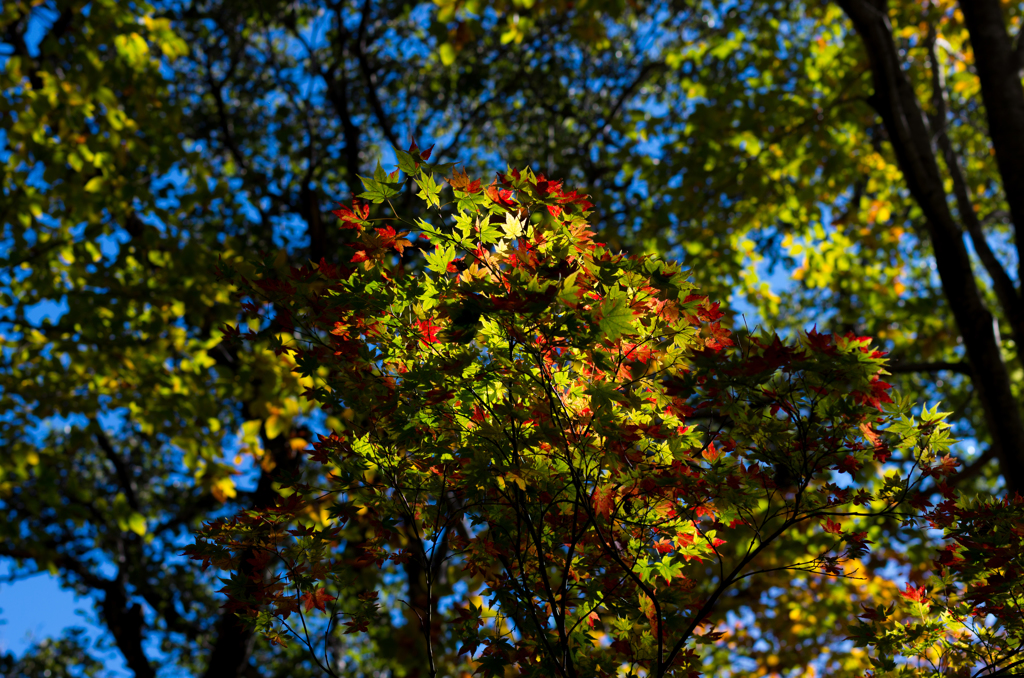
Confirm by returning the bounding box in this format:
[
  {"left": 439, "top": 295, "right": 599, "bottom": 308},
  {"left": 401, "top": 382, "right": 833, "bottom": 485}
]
[{"left": 187, "top": 157, "right": 1021, "bottom": 676}]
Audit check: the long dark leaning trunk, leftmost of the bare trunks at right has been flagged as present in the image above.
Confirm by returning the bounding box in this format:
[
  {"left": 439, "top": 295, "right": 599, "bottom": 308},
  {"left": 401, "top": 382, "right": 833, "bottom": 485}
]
[{"left": 838, "top": 0, "right": 1024, "bottom": 492}]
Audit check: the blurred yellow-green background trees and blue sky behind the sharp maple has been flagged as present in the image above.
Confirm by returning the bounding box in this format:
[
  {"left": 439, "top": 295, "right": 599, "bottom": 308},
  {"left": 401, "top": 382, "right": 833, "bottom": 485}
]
[{"left": 0, "top": 0, "right": 1024, "bottom": 678}]
